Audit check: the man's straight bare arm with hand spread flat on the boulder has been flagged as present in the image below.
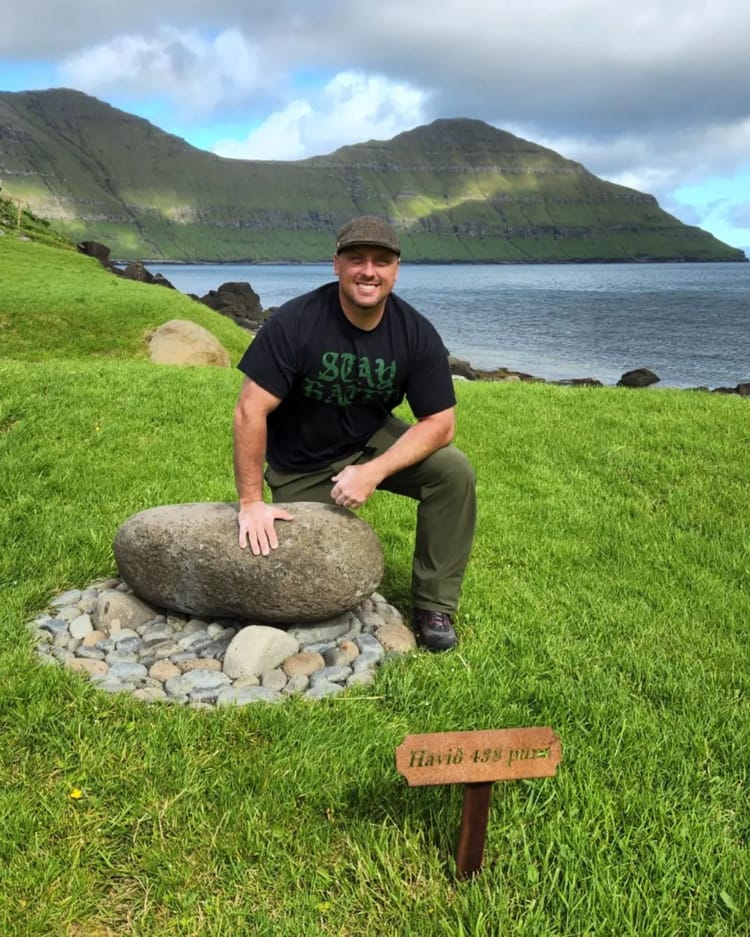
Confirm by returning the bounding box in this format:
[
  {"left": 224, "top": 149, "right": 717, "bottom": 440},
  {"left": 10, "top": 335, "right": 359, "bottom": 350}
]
[{"left": 234, "top": 378, "right": 294, "bottom": 556}]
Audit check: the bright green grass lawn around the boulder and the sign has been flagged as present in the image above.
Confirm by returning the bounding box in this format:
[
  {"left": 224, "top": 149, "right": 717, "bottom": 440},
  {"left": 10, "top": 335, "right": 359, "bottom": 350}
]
[{"left": 0, "top": 230, "right": 750, "bottom": 937}]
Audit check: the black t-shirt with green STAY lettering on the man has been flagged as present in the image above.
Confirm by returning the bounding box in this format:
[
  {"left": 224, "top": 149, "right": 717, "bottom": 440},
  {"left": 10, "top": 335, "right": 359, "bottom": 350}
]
[{"left": 238, "top": 282, "right": 456, "bottom": 472}]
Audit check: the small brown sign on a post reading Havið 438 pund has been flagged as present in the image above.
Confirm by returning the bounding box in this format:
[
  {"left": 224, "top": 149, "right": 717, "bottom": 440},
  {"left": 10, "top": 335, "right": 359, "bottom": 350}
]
[{"left": 396, "top": 726, "right": 562, "bottom": 878}]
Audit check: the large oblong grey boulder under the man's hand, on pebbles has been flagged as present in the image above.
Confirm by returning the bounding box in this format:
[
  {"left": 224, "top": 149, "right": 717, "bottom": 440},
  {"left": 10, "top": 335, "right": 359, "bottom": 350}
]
[{"left": 114, "top": 502, "right": 383, "bottom": 623}]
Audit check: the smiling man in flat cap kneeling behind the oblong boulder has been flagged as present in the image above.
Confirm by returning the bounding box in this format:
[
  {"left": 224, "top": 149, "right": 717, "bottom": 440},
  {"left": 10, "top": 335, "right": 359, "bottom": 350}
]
[{"left": 234, "top": 215, "right": 476, "bottom": 651}]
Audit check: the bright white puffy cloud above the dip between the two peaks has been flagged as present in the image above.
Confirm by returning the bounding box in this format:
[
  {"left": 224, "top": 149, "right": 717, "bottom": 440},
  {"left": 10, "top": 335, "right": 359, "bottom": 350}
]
[{"left": 214, "top": 71, "right": 427, "bottom": 159}]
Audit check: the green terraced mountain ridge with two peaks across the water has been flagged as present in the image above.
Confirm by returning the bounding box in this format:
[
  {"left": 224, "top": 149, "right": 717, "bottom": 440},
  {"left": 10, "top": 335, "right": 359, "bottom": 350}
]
[{"left": 0, "top": 90, "right": 744, "bottom": 262}]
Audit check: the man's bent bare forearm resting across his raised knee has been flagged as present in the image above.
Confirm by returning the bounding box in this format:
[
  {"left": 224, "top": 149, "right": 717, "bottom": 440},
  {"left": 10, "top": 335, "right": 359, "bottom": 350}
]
[{"left": 331, "top": 407, "right": 456, "bottom": 509}]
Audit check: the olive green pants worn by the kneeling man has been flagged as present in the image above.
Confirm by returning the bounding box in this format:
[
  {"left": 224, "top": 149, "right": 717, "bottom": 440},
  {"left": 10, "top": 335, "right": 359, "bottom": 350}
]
[{"left": 265, "top": 417, "right": 476, "bottom": 614}]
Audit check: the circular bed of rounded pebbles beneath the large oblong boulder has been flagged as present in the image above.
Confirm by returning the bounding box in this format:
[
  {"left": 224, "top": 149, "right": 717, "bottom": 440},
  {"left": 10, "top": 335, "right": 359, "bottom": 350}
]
[{"left": 29, "top": 579, "right": 416, "bottom": 709}]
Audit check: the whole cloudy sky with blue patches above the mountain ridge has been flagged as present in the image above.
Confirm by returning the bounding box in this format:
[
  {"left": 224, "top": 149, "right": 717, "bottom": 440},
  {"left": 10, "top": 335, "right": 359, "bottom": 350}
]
[{"left": 0, "top": 0, "right": 750, "bottom": 256}]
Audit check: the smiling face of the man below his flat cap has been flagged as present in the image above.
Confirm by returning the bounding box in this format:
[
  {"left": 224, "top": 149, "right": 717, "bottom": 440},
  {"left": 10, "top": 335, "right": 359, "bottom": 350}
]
[{"left": 333, "top": 246, "right": 398, "bottom": 318}]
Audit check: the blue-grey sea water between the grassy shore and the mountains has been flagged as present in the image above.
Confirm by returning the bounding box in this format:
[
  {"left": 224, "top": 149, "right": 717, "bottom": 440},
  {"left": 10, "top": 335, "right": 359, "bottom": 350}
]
[{"left": 153, "top": 263, "right": 750, "bottom": 387}]
